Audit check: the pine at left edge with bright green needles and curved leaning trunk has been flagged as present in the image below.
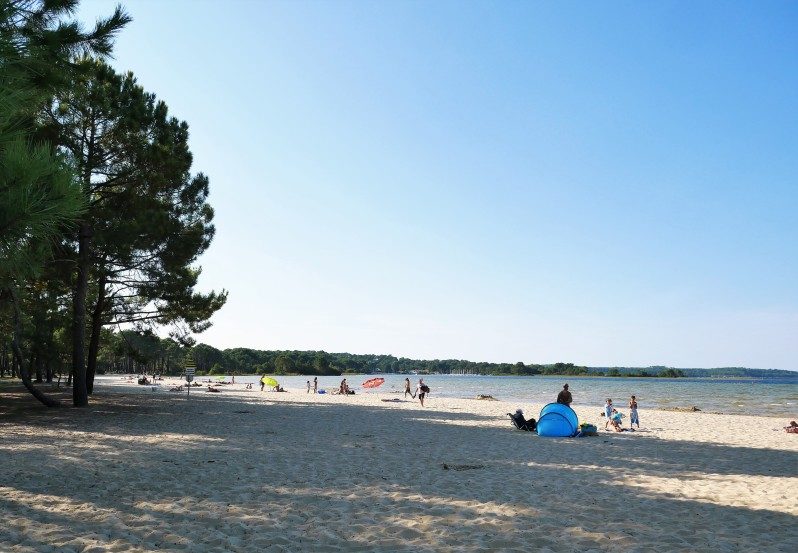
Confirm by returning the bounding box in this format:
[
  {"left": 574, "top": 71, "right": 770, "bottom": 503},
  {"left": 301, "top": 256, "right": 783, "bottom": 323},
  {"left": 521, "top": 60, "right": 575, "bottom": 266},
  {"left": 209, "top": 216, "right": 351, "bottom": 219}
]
[{"left": 0, "top": 0, "right": 129, "bottom": 405}]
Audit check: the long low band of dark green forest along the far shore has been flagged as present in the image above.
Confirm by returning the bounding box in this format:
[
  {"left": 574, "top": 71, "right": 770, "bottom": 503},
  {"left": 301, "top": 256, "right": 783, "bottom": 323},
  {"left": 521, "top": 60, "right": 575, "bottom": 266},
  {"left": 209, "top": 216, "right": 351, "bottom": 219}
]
[{"left": 0, "top": 330, "right": 796, "bottom": 378}]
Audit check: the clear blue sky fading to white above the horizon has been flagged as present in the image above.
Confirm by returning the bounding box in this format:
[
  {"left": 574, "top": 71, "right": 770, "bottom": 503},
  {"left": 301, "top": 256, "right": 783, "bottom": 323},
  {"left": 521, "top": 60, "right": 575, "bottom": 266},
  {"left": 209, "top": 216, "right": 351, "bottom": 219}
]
[{"left": 79, "top": 0, "right": 798, "bottom": 369}]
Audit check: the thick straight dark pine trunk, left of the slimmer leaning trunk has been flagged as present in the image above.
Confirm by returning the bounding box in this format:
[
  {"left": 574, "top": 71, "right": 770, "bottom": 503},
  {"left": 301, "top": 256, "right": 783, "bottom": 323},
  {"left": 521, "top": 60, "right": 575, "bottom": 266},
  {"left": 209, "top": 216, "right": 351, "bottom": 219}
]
[{"left": 72, "top": 222, "right": 92, "bottom": 407}]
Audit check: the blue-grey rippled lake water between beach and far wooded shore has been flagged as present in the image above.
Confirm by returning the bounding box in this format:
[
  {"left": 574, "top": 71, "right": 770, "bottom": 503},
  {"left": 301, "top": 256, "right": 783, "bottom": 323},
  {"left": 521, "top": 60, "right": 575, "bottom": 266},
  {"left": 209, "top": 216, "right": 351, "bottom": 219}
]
[{"left": 208, "top": 374, "right": 798, "bottom": 420}]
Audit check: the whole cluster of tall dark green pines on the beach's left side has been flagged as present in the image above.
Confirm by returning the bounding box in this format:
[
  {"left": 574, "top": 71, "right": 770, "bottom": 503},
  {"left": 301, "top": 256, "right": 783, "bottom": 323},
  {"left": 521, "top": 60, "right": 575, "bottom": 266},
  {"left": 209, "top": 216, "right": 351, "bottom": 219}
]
[{"left": 0, "top": 0, "right": 227, "bottom": 407}]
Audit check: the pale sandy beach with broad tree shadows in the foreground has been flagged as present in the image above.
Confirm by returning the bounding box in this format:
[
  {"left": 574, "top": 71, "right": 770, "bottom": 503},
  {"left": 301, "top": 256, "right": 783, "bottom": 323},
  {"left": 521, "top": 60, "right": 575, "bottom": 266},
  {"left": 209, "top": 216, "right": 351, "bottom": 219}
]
[{"left": 0, "top": 377, "right": 798, "bottom": 553}]
